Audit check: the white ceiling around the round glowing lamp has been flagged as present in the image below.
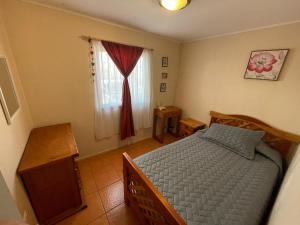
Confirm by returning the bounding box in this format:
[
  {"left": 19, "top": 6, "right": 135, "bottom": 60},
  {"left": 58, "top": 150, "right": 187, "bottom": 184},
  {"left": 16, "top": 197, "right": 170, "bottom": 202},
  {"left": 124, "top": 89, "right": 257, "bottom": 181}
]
[{"left": 27, "top": 0, "right": 300, "bottom": 41}]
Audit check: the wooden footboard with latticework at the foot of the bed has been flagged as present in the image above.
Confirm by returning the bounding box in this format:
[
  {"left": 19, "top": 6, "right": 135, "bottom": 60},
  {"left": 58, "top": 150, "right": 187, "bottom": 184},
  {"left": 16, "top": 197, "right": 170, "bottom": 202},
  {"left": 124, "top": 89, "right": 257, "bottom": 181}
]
[{"left": 123, "top": 153, "right": 186, "bottom": 225}]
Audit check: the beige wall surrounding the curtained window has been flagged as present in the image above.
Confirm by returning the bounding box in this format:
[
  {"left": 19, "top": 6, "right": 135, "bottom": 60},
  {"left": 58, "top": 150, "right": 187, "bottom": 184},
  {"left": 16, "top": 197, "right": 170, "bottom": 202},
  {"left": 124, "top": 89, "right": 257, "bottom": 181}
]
[{"left": 0, "top": 0, "right": 180, "bottom": 157}]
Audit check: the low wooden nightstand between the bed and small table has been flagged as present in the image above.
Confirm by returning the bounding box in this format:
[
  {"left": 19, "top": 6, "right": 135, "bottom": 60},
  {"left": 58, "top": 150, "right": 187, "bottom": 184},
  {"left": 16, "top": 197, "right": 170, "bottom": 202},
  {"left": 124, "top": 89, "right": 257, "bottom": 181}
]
[{"left": 179, "top": 118, "right": 206, "bottom": 137}]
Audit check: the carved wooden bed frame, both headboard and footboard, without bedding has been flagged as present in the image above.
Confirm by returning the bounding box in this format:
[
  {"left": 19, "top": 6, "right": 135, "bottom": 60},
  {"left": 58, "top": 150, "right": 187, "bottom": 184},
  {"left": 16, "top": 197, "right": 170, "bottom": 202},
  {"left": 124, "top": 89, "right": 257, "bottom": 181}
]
[{"left": 123, "top": 111, "right": 300, "bottom": 225}]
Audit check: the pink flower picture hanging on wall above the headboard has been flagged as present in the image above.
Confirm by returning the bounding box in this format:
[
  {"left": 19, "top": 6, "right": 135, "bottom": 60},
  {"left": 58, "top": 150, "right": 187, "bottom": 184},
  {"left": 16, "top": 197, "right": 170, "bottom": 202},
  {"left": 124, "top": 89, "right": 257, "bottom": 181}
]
[{"left": 245, "top": 49, "right": 289, "bottom": 80}]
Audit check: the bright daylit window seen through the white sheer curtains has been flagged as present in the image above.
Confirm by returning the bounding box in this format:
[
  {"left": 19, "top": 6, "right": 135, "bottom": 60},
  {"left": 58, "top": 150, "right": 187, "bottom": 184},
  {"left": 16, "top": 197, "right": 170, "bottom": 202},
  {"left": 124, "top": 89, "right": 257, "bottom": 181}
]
[{"left": 96, "top": 42, "right": 151, "bottom": 108}]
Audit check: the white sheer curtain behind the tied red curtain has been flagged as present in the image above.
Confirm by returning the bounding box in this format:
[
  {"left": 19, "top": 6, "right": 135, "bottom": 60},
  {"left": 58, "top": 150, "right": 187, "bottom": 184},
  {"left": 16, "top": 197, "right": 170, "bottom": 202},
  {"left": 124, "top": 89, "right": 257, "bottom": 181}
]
[{"left": 92, "top": 41, "right": 152, "bottom": 140}]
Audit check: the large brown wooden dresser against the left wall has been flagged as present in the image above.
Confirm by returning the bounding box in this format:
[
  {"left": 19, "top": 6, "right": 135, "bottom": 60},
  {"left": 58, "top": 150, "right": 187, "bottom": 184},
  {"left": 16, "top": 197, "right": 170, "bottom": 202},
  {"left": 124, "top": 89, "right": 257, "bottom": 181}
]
[{"left": 18, "top": 124, "right": 86, "bottom": 225}]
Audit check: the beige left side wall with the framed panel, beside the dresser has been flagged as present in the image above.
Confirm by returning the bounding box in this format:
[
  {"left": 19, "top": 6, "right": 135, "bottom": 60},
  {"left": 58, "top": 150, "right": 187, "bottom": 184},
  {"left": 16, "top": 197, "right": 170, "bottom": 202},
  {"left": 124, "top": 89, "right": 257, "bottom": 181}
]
[{"left": 0, "top": 11, "right": 35, "bottom": 224}]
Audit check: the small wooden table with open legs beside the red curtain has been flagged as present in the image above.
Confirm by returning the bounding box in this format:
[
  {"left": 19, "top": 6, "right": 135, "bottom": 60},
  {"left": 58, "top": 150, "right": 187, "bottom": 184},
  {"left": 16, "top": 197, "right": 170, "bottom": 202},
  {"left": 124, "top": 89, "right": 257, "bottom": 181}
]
[{"left": 152, "top": 106, "right": 181, "bottom": 143}]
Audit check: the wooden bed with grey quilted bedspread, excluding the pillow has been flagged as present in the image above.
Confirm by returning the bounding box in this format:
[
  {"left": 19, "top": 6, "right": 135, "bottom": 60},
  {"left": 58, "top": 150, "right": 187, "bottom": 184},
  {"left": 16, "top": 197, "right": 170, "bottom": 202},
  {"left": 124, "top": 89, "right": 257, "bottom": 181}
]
[{"left": 123, "top": 112, "right": 300, "bottom": 225}]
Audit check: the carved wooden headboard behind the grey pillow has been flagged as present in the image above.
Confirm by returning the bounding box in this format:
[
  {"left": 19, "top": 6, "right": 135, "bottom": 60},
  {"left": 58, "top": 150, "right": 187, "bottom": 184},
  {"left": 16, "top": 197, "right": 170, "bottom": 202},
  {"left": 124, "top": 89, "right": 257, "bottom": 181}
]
[{"left": 210, "top": 111, "right": 300, "bottom": 157}]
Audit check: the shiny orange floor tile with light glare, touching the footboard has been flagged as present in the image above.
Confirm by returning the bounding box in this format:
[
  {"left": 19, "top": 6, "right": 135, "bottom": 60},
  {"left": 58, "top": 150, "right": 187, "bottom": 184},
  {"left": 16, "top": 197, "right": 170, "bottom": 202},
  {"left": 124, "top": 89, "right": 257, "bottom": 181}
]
[{"left": 99, "top": 181, "right": 124, "bottom": 212}]
